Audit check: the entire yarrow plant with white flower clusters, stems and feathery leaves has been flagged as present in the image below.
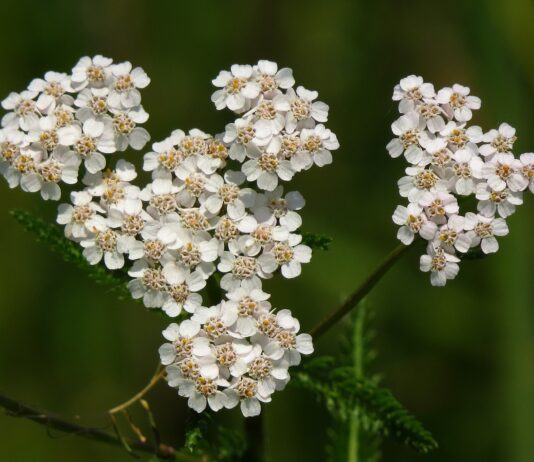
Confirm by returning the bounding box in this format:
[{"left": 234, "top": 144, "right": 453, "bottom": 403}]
[{"left": 0, "top": 56, "right": 534, "bottom": 461}]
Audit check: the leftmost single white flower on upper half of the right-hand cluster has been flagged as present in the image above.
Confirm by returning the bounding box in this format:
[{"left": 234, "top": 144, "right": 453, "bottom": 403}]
[{"left": 386, "top": 112, "right": 426, "bottom": 164}]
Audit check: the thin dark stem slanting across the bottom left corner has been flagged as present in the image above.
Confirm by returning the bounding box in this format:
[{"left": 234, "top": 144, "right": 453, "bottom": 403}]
[{"left": 0, "top": 394, "right": 201, "bottom": 462}]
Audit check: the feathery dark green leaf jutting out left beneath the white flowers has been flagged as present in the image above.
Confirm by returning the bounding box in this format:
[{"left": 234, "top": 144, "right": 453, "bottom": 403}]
[{"left": 11, "top": 210, "right": 130, "bottom": 298}]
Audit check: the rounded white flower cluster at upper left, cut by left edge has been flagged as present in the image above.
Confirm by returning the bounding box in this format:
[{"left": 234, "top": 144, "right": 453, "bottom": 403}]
[{"left": 0, "top": 56, "right": 150, "bottom": 200}]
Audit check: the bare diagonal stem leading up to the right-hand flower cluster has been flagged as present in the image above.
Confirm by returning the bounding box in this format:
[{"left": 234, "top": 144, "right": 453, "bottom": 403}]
[{"left": 310, "top": 244, "right": 412, "bottom": 338}]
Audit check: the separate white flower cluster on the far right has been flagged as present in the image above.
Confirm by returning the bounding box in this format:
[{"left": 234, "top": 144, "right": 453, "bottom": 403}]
[{"left": 387, "top": 75, "right": 534, "bottom": 286}]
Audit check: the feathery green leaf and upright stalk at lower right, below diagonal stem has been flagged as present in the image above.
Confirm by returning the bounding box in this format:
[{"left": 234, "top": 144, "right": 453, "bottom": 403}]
[{"left": 290, "top": 302, "right": 437, "bottom": 456}]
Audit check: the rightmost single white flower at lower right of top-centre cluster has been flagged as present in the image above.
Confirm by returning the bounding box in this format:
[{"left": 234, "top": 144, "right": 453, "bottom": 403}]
[{"left": 291, "top": 124, "right": 339, "bottom": 171}]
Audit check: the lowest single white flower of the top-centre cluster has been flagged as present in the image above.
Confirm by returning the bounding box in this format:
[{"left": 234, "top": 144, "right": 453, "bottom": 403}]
[{"left": 241, "top": 145, "right": 295, "bottom": 191}]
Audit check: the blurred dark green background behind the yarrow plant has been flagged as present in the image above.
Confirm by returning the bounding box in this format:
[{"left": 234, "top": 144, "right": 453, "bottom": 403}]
[{"left": 0, "top": 0, "right": 534, "bottom": 462}]
